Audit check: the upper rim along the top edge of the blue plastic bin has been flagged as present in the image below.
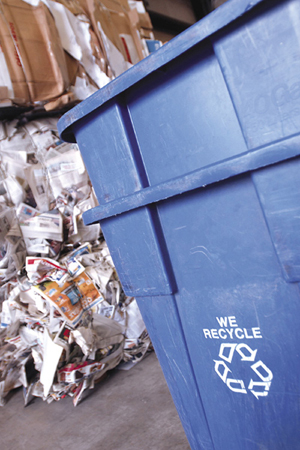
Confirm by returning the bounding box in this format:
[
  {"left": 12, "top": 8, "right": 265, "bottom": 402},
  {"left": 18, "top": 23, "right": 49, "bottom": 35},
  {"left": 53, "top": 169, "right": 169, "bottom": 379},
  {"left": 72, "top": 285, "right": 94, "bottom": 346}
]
[{"left": 58, "top": 0, "right": 265, "bottom": 143}]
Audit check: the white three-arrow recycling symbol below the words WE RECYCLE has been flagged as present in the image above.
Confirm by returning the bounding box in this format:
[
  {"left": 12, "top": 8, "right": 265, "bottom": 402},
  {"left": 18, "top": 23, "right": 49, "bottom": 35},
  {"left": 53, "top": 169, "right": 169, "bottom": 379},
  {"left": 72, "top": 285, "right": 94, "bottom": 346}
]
[{"left": 214, "top": 344, "right": 273, "bottom": 399}]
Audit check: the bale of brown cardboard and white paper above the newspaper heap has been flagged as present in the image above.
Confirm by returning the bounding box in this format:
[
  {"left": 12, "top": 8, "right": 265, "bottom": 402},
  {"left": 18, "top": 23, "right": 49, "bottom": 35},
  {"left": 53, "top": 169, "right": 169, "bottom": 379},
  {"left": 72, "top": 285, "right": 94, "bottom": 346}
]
[{"left": 0, "top": 0, "right": 158, "bottom": 110}]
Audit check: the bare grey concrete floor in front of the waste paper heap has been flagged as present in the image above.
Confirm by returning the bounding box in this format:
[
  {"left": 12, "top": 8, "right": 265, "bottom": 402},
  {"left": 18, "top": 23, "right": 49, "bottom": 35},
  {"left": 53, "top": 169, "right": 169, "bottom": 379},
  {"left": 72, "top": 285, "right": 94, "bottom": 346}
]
[{"left": 0, "top": 353, "right": 190, "bottom": 450}]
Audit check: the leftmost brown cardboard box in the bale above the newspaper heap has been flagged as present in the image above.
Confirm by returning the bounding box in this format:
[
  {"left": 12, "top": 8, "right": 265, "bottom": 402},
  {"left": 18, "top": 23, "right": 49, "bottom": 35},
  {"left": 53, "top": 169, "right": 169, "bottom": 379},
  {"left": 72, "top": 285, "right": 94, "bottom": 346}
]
[{"left": 0, "top": 0, "right": 69, "bottom": 103}]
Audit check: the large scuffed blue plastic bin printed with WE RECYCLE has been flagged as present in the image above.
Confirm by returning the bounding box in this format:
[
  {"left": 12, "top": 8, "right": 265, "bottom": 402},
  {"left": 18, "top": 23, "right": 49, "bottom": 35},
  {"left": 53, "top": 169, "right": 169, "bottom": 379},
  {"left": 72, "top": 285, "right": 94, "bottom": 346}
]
[{"left": 59, "top": 0, "right": 300, "bottom": 450}]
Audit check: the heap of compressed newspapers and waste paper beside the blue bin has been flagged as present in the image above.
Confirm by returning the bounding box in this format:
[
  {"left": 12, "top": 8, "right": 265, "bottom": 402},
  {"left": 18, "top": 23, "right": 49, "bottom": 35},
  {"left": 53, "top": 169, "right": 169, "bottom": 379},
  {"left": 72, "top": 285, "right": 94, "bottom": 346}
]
[{"left": 0, "top": 118, "right": 151, "bottom": 406}]
